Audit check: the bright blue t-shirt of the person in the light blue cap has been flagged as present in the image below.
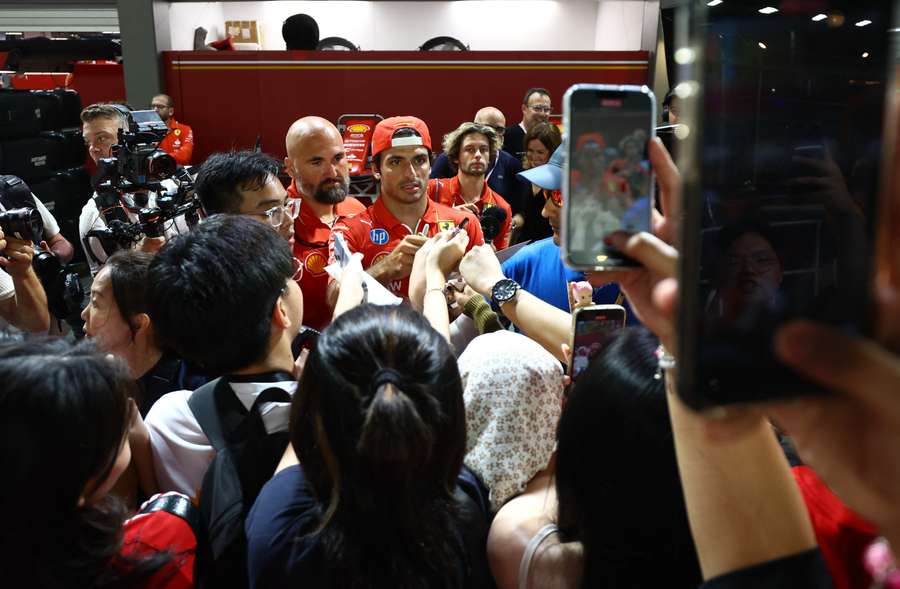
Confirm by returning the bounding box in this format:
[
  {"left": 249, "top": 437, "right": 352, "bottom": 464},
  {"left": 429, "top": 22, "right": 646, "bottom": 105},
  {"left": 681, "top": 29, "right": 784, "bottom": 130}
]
[{"left": 503, "top": 237, "right": 637, "bottom": 316}]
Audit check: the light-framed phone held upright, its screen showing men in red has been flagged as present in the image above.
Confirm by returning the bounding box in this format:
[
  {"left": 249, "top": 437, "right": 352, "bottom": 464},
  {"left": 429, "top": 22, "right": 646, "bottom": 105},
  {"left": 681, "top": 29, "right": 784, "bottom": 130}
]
[{"left": 563, "top": 84, "right": 655, "bottom": 269}]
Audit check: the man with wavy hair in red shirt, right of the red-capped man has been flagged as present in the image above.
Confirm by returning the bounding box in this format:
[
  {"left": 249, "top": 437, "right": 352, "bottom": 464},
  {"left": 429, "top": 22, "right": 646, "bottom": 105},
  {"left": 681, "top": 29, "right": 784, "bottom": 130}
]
[{"left": 428, "top": 123, "right": 512, "bottom": 250}]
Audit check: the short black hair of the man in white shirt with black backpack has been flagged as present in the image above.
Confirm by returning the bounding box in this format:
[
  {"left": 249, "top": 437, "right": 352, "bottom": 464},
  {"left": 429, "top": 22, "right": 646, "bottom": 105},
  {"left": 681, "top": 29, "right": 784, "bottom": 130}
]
[{"left": 148, "top": 215, "right": 293, "bottom": 374}]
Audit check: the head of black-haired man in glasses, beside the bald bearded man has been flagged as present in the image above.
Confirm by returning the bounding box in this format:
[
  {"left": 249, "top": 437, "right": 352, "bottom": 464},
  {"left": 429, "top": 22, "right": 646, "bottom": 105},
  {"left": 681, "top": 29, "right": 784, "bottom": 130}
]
[{"left": 194, "top": 150, "right": 300, "bottom": 245}]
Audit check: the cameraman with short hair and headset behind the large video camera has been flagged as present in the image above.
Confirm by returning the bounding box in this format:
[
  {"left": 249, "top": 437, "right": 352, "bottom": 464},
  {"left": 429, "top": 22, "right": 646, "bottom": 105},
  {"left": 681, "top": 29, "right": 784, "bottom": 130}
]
[{"left": 78, "top": 104, "right": 195, "bottom": 275}]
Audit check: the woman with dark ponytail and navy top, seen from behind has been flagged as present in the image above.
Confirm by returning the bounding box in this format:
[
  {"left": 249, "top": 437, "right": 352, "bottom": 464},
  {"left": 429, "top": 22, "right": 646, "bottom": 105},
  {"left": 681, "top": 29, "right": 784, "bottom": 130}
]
[{"left": 246, "top": 305, "right": 490, "bottom": 589}]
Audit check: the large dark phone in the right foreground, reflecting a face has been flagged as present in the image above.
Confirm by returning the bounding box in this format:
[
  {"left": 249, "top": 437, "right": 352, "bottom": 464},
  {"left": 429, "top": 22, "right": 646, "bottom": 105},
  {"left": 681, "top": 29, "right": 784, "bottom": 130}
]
[{"left": 679, "top": 0, "right": 894, "bottom": 408}]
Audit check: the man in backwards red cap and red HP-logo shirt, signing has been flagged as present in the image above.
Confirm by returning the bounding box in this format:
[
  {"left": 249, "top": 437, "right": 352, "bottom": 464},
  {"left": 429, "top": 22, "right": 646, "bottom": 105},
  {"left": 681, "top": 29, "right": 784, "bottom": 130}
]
[{"left": 329, "top": 117, "right": 484, "bottom": 301}]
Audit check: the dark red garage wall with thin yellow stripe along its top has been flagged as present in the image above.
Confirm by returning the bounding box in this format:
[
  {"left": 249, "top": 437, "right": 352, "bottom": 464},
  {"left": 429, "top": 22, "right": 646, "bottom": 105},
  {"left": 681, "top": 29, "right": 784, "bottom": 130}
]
[{"left": 163, "top": 51, "right": 649, "bottom": 163}]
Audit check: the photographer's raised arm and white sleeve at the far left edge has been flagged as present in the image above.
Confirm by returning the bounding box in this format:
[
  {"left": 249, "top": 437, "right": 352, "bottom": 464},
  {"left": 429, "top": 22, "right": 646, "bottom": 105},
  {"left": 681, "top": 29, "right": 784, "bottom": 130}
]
[{"left": 0, "top": 230, "right": 50, "bottom": 333}]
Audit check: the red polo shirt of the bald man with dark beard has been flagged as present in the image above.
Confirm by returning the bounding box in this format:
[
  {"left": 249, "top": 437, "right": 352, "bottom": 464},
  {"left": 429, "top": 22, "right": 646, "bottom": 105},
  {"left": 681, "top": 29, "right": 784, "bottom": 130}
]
[{"left": 287, "top": 181, "right": 366, "bottom": 330}]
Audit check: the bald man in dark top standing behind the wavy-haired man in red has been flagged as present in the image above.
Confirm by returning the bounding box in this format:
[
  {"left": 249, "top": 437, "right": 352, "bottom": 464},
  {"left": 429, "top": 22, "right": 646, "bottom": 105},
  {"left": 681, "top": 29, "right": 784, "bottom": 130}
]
[{"left": 431, "top": 106, "right": 531, "bottom": 218}]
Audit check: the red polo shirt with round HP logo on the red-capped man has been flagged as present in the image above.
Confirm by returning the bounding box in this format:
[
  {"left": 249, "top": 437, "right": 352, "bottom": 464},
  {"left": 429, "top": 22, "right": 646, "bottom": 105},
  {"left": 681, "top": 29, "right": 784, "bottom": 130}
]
[{"left": 330, "top": 197, "right": 484, "bottom": 299}]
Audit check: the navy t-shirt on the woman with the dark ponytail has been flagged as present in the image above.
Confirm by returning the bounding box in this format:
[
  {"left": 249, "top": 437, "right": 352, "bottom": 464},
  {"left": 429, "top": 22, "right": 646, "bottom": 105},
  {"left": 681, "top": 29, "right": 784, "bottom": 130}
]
[{"left": 244, "top": 465, "right": 490, "bottom": 589}]
